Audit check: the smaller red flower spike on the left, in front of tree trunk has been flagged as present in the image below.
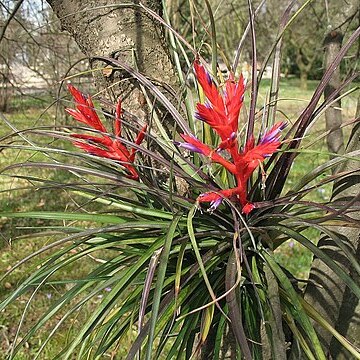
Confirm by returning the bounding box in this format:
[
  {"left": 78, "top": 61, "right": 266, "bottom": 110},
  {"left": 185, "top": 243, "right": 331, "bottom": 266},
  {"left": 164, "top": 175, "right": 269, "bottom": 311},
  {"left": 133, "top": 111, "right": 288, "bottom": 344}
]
[{"left": 65, "top": 85, "right": 146, "bottom": 180}]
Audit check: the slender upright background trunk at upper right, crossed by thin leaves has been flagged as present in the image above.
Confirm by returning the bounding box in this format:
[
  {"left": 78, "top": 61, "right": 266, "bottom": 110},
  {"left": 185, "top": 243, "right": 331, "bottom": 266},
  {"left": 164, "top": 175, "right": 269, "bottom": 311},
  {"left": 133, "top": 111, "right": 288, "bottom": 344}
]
[{"left": 324, "top": 31, "right": 344, "bottom": 159}]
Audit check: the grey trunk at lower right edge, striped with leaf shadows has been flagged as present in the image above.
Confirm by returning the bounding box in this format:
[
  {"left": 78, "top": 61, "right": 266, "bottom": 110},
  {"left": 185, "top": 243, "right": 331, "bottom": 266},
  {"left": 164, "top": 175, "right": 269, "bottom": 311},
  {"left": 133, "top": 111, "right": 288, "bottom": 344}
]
[{"left": 305, "top": 118, "right": 360, "bottom": 359}]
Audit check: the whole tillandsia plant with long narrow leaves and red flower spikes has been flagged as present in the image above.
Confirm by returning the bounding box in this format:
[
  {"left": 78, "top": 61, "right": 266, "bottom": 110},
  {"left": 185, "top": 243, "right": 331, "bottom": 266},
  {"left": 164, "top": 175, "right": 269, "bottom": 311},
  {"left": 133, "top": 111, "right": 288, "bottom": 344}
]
[{"left": 0, "top": 4, "right": 360, "bottom": 360}]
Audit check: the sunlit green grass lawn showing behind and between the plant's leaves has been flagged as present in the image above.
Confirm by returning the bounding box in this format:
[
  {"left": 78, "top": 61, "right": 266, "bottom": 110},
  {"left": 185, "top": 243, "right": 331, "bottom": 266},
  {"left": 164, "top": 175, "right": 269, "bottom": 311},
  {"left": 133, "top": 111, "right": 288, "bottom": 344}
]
[{"left": 0, "top": 79, "right": 356, "bottom": 360}]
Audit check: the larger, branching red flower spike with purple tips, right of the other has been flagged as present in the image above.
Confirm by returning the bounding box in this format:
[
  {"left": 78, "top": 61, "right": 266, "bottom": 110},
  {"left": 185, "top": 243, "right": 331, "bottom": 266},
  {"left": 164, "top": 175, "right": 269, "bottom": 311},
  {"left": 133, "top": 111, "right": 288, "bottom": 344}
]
[{"left": 178, "top": 61, "right": 286, "bottom": 214}]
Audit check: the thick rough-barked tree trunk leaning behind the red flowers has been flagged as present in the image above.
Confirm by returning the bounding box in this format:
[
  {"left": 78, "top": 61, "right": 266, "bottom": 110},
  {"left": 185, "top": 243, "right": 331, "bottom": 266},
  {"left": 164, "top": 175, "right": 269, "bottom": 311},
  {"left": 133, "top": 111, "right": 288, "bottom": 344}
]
[{"left": 48, "top": 0, "right": 177, "bottom": 119}]
